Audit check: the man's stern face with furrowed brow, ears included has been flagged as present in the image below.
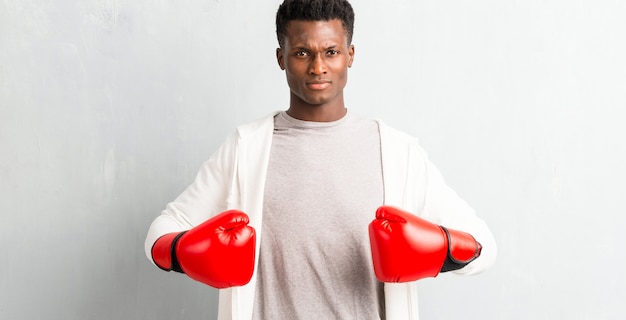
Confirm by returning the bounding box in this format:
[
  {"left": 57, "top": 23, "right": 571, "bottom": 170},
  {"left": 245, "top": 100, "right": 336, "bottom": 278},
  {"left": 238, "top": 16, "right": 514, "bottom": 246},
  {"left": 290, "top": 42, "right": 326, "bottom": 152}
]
[{"left": 276, "top": 19, "right": 354, "bottom": 107}]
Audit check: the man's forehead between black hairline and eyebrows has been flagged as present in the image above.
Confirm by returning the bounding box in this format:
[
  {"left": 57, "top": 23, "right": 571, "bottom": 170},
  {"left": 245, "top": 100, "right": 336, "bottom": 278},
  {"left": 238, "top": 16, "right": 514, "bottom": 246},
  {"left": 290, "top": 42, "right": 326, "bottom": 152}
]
[{"left": 285, "top": 19, "right": 347, "bottom": 45}]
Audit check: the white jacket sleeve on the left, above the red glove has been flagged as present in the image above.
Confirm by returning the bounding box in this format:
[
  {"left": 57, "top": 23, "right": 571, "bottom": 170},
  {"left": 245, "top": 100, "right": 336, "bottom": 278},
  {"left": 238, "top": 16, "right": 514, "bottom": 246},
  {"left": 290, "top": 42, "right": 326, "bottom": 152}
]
[{"left": 145, "top": 133, "right": 238, "bottom": 261}]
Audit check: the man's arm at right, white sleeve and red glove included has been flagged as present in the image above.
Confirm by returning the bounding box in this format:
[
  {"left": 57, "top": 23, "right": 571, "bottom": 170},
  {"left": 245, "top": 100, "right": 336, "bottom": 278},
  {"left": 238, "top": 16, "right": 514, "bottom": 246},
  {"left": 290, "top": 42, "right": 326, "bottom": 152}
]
[{"left": 370, "top": 126, "right": 497, "bottom": 282}]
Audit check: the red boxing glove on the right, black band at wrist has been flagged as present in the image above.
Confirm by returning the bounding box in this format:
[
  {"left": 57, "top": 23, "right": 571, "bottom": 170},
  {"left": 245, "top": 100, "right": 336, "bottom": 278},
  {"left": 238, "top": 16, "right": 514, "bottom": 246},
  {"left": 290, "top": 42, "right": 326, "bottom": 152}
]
[{"left": 369, "top": 206, "right": 482, "bottom": 282}]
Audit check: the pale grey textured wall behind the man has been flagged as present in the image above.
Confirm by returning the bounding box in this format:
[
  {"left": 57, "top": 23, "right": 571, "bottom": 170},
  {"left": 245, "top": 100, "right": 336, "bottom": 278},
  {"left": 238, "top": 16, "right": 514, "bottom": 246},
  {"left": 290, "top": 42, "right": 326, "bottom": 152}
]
[{"left": 0, "top": 0, "right": 626, "bottom": 320}]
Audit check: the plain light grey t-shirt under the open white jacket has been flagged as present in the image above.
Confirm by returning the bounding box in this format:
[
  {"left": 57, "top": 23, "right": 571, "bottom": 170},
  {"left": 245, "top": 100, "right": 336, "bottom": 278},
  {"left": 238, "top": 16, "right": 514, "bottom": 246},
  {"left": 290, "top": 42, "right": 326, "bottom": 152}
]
[{"left": 254, "top": 112, "right": 384, "bottom": 319}]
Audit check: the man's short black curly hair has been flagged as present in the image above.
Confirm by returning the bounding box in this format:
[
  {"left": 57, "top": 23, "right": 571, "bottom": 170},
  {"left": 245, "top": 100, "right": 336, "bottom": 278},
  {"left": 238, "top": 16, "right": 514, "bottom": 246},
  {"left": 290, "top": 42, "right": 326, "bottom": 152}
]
[{"left": 276, "top": 0, "right": 354, "bottom": 47}]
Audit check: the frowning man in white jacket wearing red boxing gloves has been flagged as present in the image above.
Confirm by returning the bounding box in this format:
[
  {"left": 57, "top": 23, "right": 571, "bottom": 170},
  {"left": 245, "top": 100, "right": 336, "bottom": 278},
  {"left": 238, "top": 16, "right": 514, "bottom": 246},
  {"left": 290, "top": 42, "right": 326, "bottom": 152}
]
[{"left": 146, "top": 0, "right": 496, "bottom": 319}]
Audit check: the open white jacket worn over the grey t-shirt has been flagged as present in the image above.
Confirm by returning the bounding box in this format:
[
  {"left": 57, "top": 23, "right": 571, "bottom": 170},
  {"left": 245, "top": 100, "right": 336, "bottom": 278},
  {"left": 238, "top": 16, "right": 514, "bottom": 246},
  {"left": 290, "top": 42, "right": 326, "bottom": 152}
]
[{"left": 145, "top": 115, "right": 497, "bottom": 320}]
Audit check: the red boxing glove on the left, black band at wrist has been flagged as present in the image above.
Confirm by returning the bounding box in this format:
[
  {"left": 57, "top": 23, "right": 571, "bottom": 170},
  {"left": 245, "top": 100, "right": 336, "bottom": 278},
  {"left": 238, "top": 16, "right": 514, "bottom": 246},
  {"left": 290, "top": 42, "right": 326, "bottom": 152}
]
[{"left": 152, "top": 210, "right": 256, "bottom": 289}]
